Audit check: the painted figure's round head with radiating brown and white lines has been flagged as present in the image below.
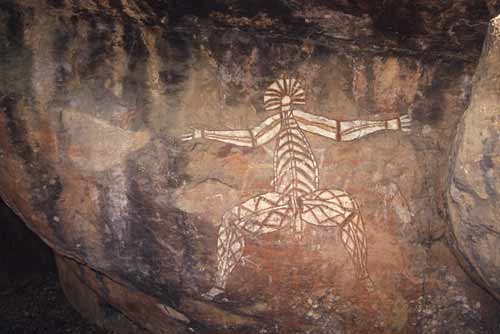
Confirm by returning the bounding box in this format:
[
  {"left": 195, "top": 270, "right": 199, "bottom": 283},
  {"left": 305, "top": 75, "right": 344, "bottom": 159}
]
[{"left": 264, "top": 77, "right": 306, "bottom": 111}]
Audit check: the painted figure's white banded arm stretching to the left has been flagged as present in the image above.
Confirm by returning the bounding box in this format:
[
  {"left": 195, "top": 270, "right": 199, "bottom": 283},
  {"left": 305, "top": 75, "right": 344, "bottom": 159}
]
[{"left": 181, "top": 114, "right": 281, "bottom": 147}]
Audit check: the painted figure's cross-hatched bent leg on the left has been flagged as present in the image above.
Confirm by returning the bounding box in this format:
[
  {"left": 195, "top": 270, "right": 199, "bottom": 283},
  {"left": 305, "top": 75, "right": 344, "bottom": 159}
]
[{"left": 206, "top": 193, "right": 291, "bottom": 297}]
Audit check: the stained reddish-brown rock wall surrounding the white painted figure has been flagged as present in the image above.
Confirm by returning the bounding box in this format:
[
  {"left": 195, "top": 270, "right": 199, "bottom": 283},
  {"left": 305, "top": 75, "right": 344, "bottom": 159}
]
[{"left": 0, "top": 0, "right": 498, "bottom": 333}]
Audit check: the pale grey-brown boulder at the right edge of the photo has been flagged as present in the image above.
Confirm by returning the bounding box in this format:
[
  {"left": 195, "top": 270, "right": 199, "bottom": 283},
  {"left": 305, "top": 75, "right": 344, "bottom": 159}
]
[{"left": 448, "top": 17, "right": 500, "bottom": 298}]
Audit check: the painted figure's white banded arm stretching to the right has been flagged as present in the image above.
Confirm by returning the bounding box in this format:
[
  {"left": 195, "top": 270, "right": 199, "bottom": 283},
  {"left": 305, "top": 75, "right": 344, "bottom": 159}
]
[{"left": 294, "top": 110, "right": 411, "bottom": 141}]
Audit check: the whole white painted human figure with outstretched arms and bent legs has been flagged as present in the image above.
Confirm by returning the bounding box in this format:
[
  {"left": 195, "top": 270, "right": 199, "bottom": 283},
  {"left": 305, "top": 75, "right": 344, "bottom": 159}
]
[{"left": 182, "top": 77, "right": 411, "bottom": 297}]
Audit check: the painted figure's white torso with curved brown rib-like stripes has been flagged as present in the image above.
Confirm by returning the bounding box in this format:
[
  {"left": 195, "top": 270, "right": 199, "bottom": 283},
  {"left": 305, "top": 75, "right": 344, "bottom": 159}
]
[{"left": 274, "top": 112, "right": 318, "bottom": 198}]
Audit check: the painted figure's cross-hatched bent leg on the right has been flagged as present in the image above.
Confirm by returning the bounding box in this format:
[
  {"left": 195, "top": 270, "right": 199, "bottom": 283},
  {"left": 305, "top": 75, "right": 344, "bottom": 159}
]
[{"left": 302, "top": 189, "right": 371, "bottom": 283}]
